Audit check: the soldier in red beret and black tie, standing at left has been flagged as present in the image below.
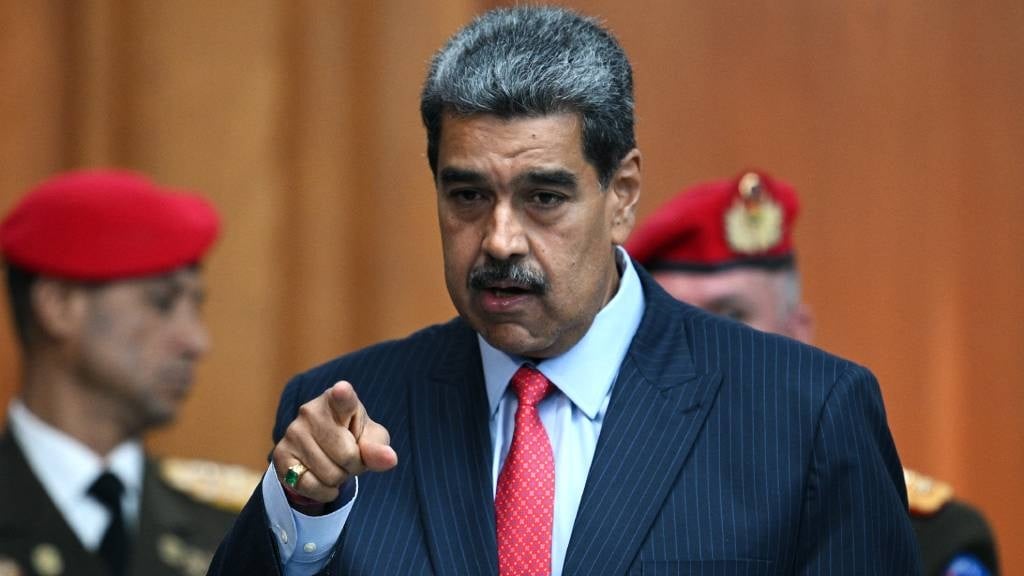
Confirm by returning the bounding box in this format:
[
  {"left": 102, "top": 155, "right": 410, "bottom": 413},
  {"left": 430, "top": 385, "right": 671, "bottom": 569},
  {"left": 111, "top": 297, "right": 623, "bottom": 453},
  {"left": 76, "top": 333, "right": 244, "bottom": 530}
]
[{"left": 0, "top": 170, "right": 259, "bottom": 576}]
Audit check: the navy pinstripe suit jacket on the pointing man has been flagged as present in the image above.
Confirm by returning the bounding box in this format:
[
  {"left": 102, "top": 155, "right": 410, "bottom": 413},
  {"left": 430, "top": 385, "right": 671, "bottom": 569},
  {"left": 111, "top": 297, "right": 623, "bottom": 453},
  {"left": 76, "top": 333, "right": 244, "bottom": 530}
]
[{"left": 211, "top": 270, "right": 919, "bottom": 575}]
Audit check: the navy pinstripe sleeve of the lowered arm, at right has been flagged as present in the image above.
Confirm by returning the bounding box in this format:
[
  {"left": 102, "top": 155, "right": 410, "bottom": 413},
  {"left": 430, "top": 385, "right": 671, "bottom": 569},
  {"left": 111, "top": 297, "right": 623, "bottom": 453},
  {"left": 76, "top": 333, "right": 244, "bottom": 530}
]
[{"left": 796, "top": 365, "right": 921, "bottom": 575}]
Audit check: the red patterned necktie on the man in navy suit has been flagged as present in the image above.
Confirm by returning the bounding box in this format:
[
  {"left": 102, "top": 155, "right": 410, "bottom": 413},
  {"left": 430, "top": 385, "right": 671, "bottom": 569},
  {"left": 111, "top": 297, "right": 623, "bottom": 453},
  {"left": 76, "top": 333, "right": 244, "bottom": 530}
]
[{"left": 495, "top": 365, "right": 555, "bottom": 576}]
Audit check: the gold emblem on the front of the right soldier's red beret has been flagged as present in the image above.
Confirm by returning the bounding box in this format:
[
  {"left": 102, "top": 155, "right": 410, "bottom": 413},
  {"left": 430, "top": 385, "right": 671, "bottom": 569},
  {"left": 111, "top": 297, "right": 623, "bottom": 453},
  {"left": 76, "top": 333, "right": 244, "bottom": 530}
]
[{"left": 725, "top": 172, "right": 782, "bottom": 254}]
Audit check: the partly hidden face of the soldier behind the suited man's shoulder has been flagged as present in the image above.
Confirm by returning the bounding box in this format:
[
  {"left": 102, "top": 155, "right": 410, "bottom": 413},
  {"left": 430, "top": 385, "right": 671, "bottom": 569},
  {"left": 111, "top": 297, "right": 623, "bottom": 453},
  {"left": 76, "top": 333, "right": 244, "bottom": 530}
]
[{"left": 653, "top": 269, "right": 811, "bottom": 341}]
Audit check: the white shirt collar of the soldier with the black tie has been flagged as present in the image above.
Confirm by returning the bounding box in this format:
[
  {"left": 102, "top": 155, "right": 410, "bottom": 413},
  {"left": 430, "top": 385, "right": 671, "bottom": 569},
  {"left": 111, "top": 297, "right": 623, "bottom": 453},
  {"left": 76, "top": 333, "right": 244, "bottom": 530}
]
[{"left": 8, "top": 399, "right": 145, "bottom": 507}]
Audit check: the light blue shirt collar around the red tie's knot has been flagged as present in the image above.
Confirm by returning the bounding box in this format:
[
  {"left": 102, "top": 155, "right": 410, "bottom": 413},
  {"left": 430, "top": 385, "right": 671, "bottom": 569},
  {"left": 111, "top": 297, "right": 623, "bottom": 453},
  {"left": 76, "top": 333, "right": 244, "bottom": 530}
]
[{"left": 477, "top": 247, "right": 644, "bottom": 419}]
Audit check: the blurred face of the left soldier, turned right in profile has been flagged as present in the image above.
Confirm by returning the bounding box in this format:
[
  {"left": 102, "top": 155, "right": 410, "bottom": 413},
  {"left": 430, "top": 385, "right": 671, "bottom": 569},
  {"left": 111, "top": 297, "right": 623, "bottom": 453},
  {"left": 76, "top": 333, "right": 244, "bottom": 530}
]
[{"left": 76, "top": 268, "right": 209, "bottom": 431}]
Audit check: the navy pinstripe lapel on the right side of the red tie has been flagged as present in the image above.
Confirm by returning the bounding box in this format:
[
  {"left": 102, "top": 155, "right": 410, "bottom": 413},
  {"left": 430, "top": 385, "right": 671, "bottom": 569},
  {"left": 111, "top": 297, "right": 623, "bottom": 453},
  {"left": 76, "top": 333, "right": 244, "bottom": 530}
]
[{"left": 563, "top": 271, "right": 721, "bottom": 574}]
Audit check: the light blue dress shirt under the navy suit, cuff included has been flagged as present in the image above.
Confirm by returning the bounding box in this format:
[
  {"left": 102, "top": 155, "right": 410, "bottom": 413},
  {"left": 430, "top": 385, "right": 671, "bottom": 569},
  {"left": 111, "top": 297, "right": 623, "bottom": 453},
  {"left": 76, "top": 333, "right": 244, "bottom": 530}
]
[{"left": 262, "top": 248, "right": 644, "bottom": 576}]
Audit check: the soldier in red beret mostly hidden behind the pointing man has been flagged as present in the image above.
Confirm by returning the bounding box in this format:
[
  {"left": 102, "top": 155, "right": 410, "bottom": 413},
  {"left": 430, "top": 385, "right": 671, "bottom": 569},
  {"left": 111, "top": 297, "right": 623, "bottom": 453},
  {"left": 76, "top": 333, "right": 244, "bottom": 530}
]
[{"left": 626, "top": 168, "right": 998, "bottom": 576}]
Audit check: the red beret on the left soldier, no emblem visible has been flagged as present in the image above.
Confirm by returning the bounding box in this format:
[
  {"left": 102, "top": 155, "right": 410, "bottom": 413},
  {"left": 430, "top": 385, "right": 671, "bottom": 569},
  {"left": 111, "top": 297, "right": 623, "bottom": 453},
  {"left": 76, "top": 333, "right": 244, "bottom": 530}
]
[{"left": 0, "top": 170, "right": 220, "bottom": 281}]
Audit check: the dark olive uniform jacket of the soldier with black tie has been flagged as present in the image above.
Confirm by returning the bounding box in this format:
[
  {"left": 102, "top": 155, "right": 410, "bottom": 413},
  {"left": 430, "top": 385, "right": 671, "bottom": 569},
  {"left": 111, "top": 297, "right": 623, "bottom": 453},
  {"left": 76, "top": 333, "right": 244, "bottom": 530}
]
[{"left": 0, "top": 433, "right": 260, "bottom": 576}]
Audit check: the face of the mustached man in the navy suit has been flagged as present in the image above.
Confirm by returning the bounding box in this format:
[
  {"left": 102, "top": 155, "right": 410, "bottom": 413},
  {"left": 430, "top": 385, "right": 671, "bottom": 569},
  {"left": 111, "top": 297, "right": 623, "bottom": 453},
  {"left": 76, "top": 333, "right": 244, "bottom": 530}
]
[{"left": 437, "top": 114, "right": 640, "bottom": 358}]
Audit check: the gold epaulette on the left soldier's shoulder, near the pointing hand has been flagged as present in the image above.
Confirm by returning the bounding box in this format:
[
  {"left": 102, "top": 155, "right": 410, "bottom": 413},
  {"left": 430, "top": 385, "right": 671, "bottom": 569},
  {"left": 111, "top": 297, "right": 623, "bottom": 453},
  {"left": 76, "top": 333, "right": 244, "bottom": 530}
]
[{"left": 160, "top": 458, "right": 263, "bottom": 512}]
